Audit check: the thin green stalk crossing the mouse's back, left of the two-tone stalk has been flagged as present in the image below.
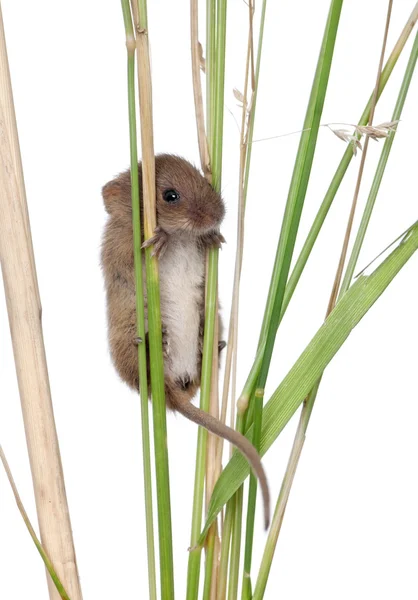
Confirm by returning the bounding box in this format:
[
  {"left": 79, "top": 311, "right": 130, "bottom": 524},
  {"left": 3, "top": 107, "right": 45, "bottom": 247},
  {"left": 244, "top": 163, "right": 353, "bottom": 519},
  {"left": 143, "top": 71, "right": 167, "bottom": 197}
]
[{"left": 122, "top": 0, "right": 157, "bottom": 600}]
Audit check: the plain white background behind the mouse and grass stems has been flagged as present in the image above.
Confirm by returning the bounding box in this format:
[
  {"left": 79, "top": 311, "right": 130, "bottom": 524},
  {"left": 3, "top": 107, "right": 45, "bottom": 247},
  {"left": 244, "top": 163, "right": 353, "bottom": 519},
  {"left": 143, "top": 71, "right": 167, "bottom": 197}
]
[{"left": 0, "top": 0, "right": 418, "bottom": 600}]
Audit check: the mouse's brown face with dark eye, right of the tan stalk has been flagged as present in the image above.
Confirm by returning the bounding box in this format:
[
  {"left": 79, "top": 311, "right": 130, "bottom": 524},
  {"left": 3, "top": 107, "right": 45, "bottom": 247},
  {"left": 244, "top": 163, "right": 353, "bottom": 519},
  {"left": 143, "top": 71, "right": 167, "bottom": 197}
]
[{"left": 155, "top": 154, "right": 225, "bottom": 236}]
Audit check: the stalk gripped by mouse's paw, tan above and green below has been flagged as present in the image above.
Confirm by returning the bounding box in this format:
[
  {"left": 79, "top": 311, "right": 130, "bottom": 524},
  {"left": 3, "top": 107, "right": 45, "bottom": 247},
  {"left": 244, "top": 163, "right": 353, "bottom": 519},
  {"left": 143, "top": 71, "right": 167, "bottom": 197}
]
[{"left": 132, "top": 0, "right": 174, "bottom": 600}]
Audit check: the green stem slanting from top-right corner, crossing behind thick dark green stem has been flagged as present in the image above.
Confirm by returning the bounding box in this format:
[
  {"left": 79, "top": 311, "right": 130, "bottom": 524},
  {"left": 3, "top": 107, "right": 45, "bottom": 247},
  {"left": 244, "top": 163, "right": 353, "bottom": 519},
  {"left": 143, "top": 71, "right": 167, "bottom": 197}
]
[{"left": 238, "top": 4, "right": 418, "bottom": 410}]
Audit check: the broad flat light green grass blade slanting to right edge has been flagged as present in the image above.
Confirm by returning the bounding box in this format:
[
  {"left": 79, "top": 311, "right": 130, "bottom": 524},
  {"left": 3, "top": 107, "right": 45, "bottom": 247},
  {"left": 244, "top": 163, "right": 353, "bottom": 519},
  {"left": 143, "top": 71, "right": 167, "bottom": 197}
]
[{"left": 200, "top": 223, "right": 418, "bottom": 542}]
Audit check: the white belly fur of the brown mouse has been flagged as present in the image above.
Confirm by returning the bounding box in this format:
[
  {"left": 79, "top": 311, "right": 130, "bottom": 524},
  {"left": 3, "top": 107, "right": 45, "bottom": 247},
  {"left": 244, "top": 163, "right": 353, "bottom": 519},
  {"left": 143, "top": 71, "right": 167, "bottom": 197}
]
[{"left": 160, "top": 236, "right": 204, "bottom": 380}]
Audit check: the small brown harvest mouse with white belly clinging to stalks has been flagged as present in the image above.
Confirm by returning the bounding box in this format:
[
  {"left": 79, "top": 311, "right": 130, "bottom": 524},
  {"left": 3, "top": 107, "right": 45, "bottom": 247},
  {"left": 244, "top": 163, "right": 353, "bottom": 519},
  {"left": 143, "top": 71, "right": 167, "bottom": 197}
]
[{"left": 102, "top": 154, "right": 270, "bottom": 528}]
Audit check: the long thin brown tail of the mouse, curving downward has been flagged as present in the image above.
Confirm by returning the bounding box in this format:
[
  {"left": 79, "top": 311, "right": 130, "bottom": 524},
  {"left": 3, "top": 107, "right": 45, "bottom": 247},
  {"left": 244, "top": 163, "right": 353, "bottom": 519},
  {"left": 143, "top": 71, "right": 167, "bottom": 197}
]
[{"left": 174, "top": 402, "right": 270, "bottom": 529}]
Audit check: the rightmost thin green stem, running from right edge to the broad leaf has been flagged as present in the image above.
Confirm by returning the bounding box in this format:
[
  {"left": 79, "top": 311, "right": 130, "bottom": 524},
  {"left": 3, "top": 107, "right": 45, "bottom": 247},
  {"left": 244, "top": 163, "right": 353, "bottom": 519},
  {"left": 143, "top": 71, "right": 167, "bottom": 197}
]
[{"left": 339, "top": 27, "right": 418, "bottom": 297}]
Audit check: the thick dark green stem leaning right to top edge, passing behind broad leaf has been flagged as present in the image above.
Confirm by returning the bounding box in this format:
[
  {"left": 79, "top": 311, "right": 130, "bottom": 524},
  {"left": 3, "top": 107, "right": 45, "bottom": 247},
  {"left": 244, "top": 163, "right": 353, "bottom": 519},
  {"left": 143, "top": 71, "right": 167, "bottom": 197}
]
[{"left": 242, "top": 0, "right": 343, "bottom": 584}]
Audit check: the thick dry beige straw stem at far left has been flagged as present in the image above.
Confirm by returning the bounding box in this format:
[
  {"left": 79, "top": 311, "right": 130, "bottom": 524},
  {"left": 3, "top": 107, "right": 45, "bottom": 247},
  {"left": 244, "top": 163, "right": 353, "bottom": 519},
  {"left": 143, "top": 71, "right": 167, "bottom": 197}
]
[{"left": 0, "top": 11, "right": 82, "bottom": 600}]
